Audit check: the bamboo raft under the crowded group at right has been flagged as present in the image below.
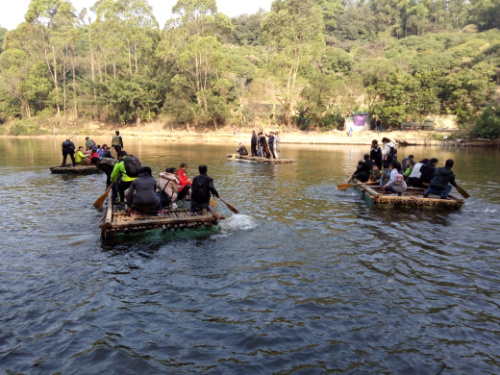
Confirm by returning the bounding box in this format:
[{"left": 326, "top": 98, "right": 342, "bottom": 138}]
[{"left": 353, "top": 183, "right": 464, "bottom": 209}]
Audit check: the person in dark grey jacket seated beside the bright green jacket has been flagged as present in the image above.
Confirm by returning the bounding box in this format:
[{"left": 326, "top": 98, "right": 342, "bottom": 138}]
[{"left": 127, "top": 167, "right": 163, "bottom": 215}]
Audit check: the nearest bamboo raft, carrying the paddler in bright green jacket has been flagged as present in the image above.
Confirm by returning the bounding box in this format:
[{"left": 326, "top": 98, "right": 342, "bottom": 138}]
[{"left": 99, "top": 192, "right": 217, "bottom": 241}]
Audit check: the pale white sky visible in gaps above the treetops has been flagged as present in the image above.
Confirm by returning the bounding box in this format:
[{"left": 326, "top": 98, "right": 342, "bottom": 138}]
[{"left": 0, "top": 0, "right": 272, "bottom": 30}]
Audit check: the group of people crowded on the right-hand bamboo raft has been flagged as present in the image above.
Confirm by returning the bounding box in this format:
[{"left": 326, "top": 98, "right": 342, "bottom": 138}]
[{"left": 352, "top": 137, "right": 457, "bottom": 199}]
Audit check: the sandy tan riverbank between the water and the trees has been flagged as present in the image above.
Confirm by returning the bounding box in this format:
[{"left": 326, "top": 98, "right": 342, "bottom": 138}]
[{"left": 4, "top": 122, "right": 500, "bottom": 147}]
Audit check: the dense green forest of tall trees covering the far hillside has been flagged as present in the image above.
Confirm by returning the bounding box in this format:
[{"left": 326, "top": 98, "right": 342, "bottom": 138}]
[{"left": 0, "top": 0, "right": 500, "bottom": 138}]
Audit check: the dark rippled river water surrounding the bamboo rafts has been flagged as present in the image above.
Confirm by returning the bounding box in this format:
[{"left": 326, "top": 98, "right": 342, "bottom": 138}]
[{"left": 0, "top": 138, "right": 500, "bottom": 374}]
